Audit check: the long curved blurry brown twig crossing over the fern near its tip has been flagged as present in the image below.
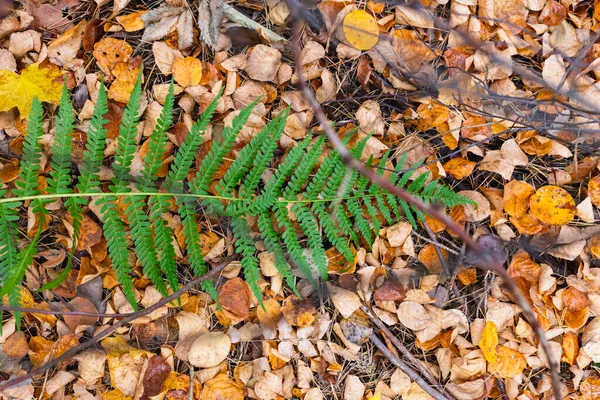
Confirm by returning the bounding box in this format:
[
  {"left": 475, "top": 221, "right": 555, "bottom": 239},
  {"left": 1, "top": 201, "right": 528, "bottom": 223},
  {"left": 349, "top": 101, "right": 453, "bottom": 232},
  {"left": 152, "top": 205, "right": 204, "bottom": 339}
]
[{"left": 286, "top": 0, "right": 561, "bottom": 399}]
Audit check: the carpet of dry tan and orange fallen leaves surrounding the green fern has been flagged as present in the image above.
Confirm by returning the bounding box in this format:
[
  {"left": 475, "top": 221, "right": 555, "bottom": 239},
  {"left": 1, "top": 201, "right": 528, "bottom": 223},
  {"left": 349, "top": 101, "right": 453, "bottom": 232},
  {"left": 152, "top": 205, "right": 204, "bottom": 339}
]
[{"left": 0, "top": 0, "right": 600, "bottom": 400}]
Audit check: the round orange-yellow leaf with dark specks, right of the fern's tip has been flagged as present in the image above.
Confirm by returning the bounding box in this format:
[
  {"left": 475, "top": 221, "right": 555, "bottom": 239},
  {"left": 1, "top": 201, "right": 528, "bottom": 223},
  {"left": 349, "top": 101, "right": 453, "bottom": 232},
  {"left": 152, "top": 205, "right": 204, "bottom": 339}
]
[{"left": 529, "top": 185, "right": 577, "bottom": 225}]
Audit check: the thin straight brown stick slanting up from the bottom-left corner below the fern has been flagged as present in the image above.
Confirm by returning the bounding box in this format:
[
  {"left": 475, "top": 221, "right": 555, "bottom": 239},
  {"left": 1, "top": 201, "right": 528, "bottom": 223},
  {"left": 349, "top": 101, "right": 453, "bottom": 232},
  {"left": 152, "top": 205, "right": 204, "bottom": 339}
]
[{"left": 0, "top": 255, "right": 237, "bottom": 391}]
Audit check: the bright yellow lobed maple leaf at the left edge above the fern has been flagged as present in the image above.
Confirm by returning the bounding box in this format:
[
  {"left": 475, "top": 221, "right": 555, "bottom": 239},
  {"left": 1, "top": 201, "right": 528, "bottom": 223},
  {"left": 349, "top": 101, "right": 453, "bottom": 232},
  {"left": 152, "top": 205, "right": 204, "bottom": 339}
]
[{"left": 0, "top": 64, "right": 62, "bottom": 118}]
